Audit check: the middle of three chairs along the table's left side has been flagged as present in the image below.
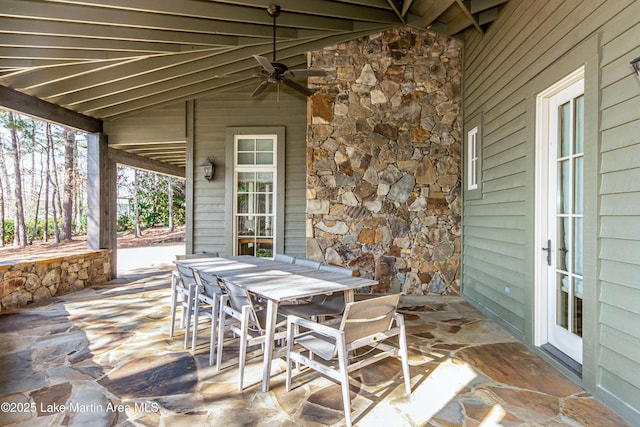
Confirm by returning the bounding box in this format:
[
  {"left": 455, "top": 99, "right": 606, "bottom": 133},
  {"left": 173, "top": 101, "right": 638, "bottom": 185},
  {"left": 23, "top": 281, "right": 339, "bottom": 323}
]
[{"left": 189, "top": 270, "right": 224, "bottom": 366}]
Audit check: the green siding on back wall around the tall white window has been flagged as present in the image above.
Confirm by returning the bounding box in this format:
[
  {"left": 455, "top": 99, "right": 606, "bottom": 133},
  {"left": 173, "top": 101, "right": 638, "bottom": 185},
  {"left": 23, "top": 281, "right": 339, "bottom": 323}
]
[{"left": 193, "top": 88, "right": 307, "bottom": 256}]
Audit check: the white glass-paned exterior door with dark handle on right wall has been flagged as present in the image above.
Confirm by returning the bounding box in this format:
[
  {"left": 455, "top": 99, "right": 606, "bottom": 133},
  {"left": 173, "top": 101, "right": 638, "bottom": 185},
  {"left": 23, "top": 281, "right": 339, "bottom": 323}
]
[{"left": 537, "top": 71, "right": 584, "bottom": 364}]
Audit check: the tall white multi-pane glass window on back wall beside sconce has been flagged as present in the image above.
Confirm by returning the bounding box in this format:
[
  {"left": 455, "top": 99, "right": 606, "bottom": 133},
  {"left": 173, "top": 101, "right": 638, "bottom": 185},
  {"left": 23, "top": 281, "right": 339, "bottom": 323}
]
[{"left": 233, "top": 135, "right": 278, "bottom": 257}]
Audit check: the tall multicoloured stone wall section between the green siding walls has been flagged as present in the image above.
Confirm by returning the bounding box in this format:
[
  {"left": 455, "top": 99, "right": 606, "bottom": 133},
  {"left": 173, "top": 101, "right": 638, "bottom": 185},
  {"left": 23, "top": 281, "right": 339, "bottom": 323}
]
[{"left": 307, "top": 27, "right": 462, "bottom": 294}]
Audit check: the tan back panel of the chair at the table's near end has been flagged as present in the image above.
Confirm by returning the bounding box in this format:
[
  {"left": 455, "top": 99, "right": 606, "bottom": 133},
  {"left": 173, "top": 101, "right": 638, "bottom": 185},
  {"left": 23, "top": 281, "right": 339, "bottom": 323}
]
[{"left": 340, "top": 294, "right": 400, "bottom": 343}]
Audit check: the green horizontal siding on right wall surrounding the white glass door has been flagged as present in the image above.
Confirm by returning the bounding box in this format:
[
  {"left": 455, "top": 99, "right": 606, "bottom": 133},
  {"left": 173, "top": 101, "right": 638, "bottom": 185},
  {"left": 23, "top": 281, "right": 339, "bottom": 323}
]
[{"left": 462, "top": 0, "right": 640, "bottom": 420}]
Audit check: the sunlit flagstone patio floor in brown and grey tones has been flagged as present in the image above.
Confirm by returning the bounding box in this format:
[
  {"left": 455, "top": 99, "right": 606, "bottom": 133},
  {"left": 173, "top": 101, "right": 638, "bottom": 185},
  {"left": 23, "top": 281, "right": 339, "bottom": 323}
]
[{"left": 0, "top": 265, "right": 628, "bottom": 427}]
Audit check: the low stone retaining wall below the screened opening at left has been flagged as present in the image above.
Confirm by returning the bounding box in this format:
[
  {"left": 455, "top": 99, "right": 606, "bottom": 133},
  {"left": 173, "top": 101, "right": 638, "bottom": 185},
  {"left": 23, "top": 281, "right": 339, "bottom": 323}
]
[{"left": 0, "top": 249, "right": 111, "bottom": 312}]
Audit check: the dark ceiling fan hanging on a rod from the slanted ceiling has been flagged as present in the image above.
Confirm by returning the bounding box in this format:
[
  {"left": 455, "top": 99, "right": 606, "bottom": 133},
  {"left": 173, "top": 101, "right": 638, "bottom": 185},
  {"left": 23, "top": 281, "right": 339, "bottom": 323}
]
[{"left": 251, "top": 4, "right": 327, "bottom": 96}]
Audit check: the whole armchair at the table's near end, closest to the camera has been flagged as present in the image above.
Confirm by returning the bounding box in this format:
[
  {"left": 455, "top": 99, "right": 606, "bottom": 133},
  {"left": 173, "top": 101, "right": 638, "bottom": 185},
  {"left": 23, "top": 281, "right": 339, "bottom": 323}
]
[{"left": 286, "top": 294, "right": 411, "bottom": 426}]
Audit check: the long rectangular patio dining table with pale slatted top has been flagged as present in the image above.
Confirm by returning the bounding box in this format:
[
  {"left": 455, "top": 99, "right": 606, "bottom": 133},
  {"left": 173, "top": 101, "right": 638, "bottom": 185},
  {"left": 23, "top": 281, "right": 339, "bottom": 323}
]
[{"left": 174, "top": 255, "right": 378, "bottom": 391}]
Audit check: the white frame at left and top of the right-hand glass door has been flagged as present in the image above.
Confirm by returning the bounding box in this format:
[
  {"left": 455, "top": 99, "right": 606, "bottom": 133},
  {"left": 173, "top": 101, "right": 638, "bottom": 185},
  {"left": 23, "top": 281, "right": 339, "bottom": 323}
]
[{"left": 533, "top": 66, "right": 585, "bottom": 346}]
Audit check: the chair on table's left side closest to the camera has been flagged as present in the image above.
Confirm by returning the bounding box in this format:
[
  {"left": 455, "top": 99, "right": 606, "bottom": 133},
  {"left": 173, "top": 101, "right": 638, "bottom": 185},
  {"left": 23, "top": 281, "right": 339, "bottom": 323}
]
[{"left": 216, "top": 281, "right": 286, "bottom": 391}]
